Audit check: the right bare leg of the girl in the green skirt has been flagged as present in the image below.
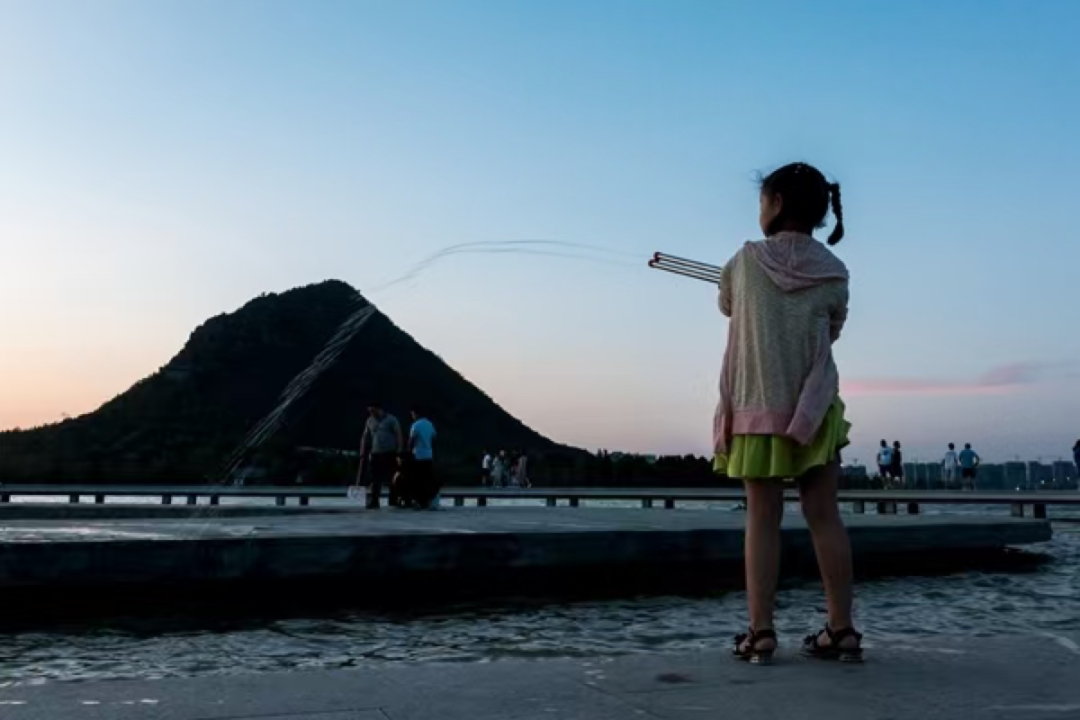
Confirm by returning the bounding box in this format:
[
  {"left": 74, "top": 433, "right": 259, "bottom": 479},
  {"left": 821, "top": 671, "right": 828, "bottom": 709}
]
[{"left": 799, "top": 462, "right": 856, "bottom": 646}]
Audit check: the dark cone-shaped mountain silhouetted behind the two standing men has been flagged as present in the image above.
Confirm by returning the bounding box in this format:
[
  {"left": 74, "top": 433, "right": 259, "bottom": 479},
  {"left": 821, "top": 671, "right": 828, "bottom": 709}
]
[{"left": 0, "top": 280, "right": 574, "bottom": 483}]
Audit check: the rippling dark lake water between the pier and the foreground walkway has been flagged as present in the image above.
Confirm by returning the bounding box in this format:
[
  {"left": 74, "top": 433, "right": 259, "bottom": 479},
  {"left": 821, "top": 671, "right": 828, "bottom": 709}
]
[{"left": 0, "top": 500, "right": 1080, "bottom": 684}]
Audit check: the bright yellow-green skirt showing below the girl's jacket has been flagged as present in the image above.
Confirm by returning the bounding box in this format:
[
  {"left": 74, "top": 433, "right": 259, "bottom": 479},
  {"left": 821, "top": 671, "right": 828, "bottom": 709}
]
[{"left": 713, "top": 397, "right": 851, "bottom": 480}]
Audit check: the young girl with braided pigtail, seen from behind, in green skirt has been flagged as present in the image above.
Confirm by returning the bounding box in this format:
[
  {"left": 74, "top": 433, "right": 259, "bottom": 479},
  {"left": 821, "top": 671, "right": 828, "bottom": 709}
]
[{"left": 714, "top": 163, "right": 862, "bottom": 664}]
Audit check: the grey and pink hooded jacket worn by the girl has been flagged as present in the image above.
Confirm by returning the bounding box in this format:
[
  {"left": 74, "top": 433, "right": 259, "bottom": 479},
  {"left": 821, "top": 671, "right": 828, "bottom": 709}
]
[{"left": 713, "top": 232, "right": 848, "bottom": 453}]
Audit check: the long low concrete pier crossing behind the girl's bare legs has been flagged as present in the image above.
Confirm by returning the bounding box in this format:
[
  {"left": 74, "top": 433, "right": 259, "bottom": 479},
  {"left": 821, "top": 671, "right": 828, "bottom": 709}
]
[{"left": 0, "top": 506, "right": 1051, "bottom": 588}]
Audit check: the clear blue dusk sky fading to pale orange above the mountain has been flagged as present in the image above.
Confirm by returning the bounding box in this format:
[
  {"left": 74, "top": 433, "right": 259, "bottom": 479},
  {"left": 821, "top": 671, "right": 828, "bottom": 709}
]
[{"left": 0, "top": 0, "right": 1080, "bottom": 462}]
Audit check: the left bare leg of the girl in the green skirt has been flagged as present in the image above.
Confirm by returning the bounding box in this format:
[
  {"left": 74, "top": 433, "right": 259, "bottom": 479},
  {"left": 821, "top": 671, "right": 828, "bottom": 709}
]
[{"left": 745, "top": 480, "right": 784, "bottom": 650}]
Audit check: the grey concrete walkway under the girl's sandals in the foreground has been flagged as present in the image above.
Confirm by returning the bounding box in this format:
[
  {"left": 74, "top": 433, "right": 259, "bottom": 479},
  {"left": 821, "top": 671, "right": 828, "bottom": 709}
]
[{"left": 0, "top": 637, "right": 1080, "bottom": 720}]
